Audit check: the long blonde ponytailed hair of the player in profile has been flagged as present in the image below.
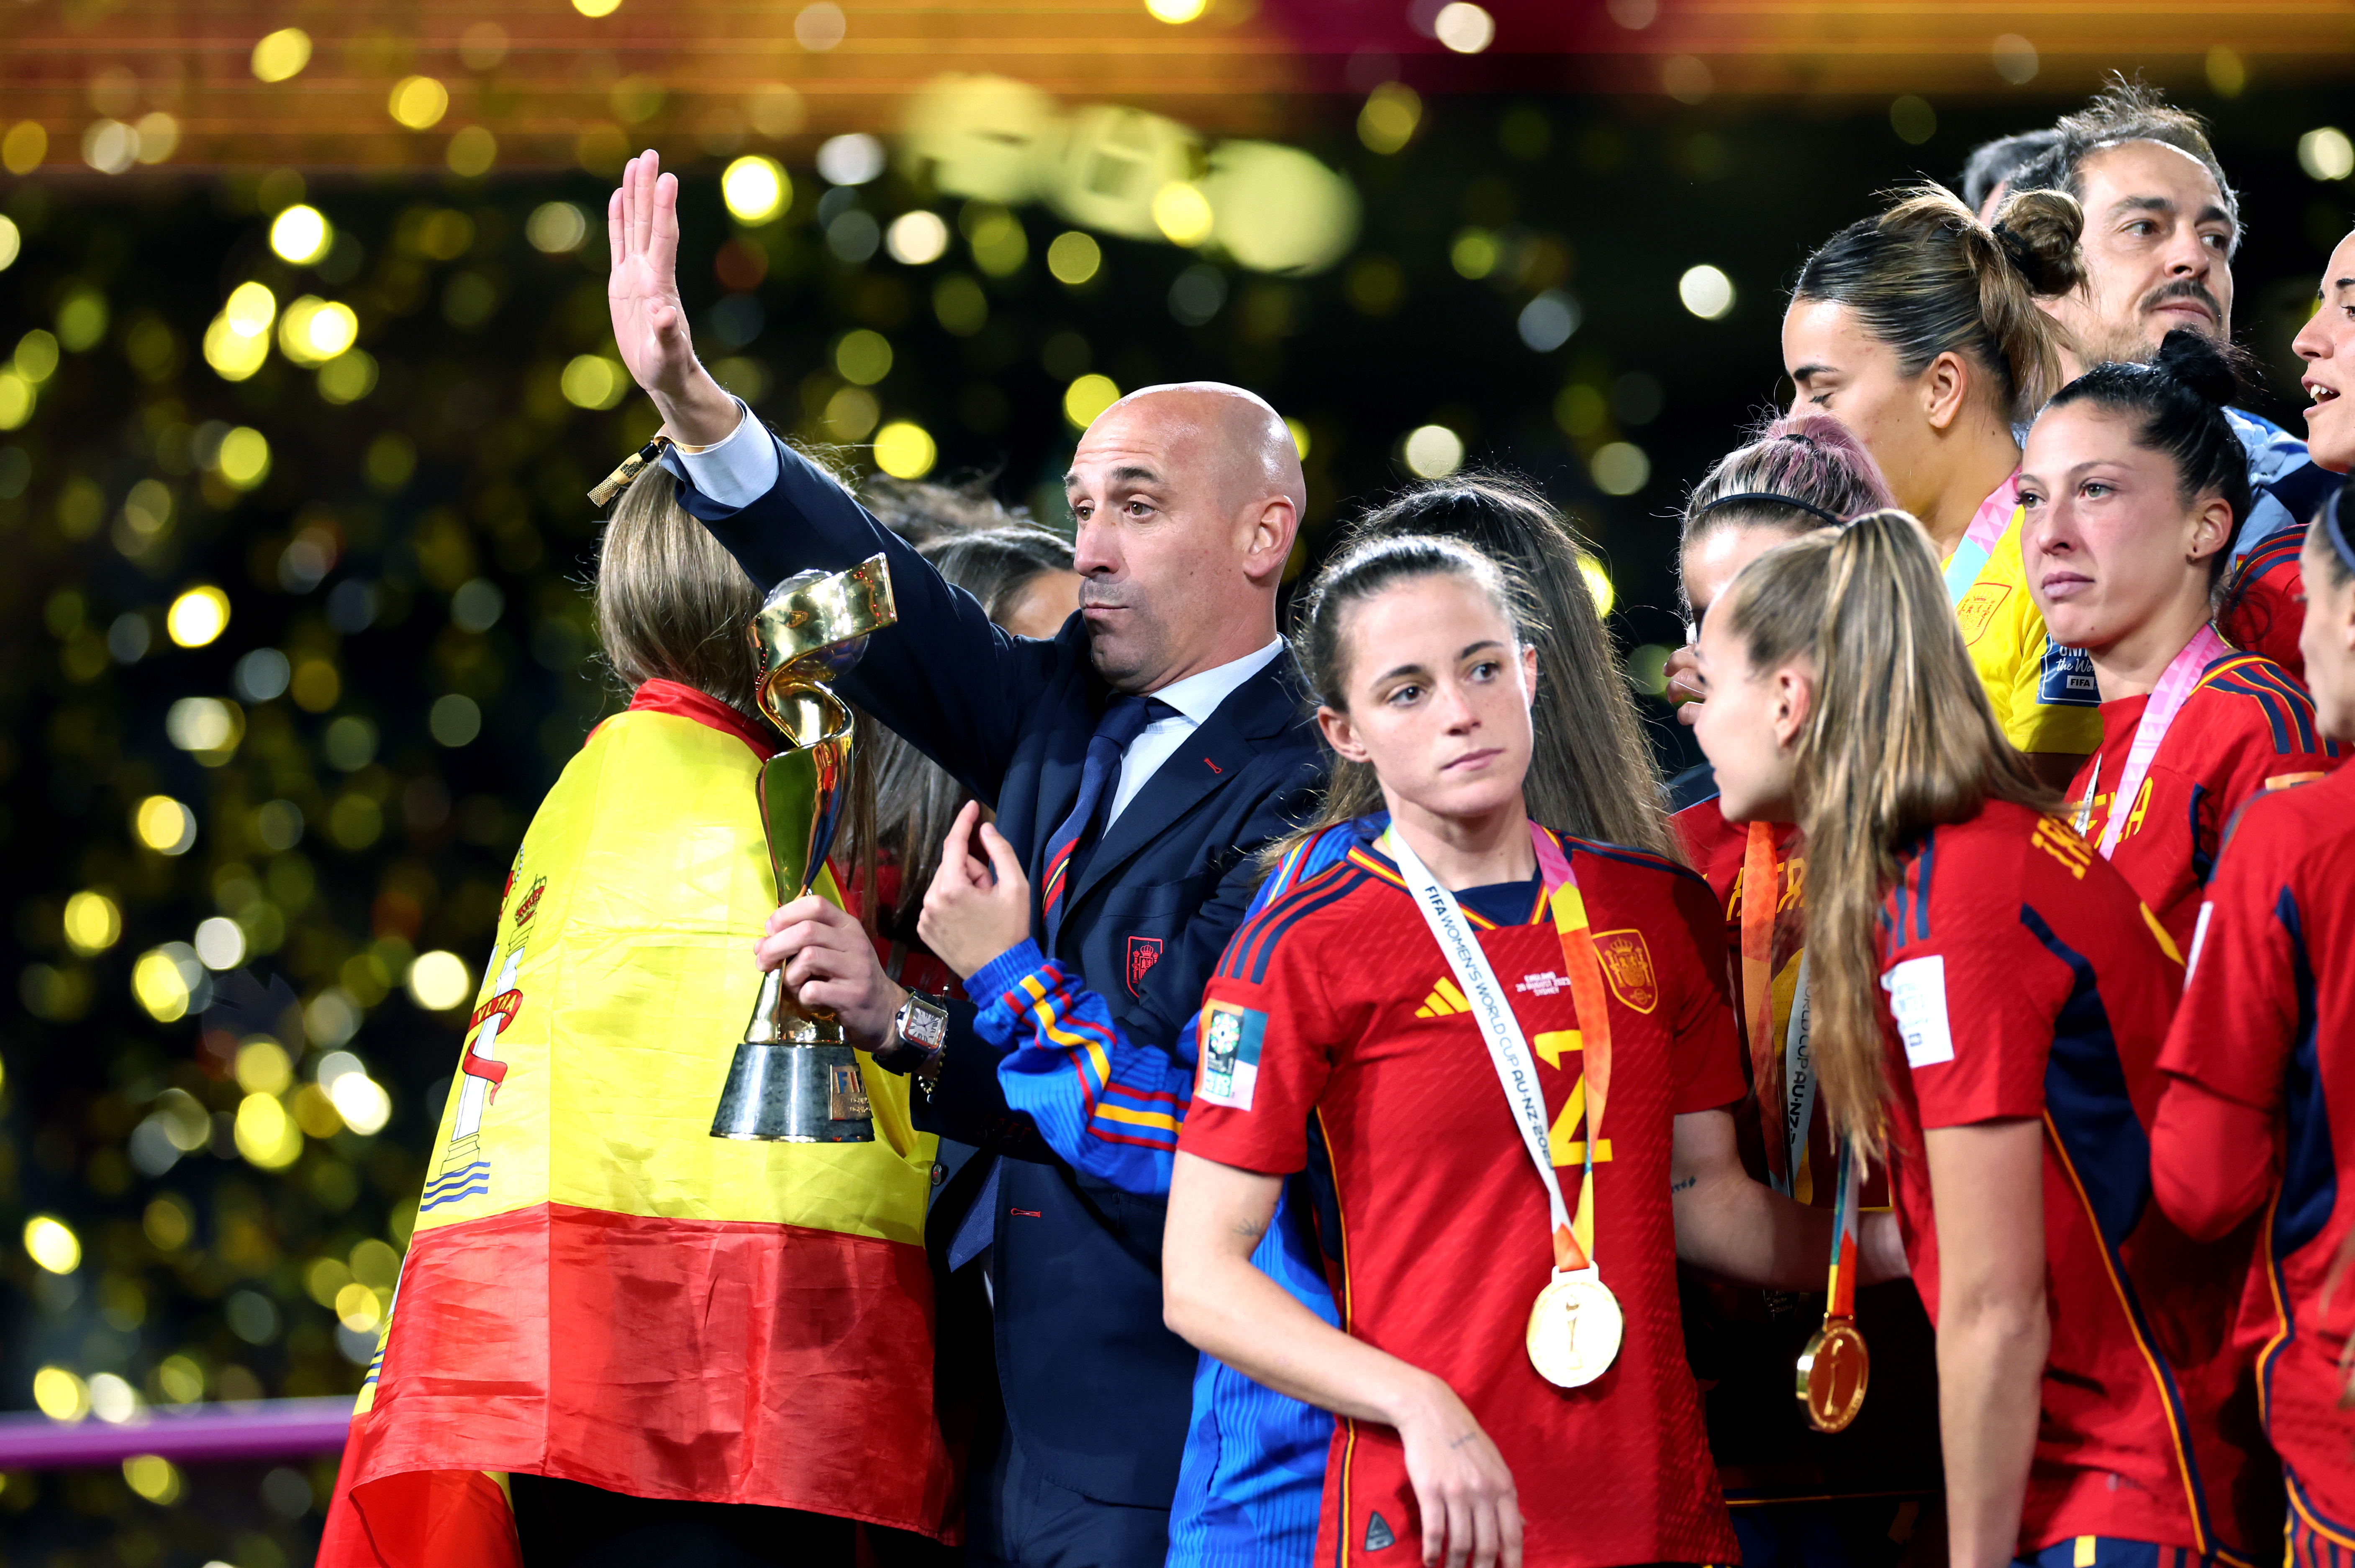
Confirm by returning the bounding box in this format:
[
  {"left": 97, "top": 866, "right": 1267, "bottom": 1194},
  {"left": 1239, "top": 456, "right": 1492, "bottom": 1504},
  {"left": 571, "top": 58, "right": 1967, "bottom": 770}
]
[{"left": 1712, "top": 509, "right": 2061, "bottom": 1154}]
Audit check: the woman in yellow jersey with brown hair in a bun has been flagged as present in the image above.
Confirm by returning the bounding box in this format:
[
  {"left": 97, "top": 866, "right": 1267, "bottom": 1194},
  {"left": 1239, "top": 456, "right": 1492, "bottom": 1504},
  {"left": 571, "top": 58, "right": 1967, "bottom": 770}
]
[{"left": 1783, "top": 186, "right": 2101, "bottom": 784}]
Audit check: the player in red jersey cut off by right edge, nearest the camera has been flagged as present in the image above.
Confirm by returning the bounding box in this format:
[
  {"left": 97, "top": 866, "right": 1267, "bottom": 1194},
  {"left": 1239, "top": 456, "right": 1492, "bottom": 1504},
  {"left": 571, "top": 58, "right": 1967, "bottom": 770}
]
[{"left": 2150, "top": 490, "right": 2355, "bottom": 1568}]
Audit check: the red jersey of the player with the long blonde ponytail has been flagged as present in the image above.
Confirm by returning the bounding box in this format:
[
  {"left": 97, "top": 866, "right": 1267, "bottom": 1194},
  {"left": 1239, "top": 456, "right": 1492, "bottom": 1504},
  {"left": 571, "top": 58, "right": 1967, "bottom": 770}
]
[{"left": 1879, "top": 800, "right": 2214, "bottom": 1556}]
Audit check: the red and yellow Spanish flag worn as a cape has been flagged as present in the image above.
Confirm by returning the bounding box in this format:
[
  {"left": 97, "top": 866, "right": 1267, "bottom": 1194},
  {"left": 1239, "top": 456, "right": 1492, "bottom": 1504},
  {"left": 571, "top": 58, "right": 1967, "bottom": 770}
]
[{"left": 318, "top": 680, "right": 954, "bottom": 1568}]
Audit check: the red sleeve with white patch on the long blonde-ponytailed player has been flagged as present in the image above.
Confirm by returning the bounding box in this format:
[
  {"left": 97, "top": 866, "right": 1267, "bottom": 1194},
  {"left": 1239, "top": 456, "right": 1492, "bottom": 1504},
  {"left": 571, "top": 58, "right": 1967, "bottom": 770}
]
[{"left": 1882, "top": 831, "right": 2065, "bottom": 1128}]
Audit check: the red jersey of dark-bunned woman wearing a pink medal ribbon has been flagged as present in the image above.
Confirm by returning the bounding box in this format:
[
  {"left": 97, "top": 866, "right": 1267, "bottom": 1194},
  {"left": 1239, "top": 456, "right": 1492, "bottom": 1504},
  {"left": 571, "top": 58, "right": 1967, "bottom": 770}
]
[{"left": 2070, "top": 654, "right": 2345, "bottom": 953}]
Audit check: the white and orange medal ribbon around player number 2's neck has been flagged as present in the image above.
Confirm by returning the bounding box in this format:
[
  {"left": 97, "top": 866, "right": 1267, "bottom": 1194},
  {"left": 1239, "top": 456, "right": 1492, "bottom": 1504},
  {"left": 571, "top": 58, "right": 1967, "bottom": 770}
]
[{"left": 1375, "top": 822, "right": 1611, "bottom": 1278}]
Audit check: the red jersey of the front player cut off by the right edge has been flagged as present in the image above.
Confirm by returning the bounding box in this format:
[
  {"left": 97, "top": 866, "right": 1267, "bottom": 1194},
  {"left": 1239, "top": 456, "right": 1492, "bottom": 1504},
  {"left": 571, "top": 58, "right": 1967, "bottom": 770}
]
[{"left": 2152, "top": 772, "right": 2355, "bottom": 1540}]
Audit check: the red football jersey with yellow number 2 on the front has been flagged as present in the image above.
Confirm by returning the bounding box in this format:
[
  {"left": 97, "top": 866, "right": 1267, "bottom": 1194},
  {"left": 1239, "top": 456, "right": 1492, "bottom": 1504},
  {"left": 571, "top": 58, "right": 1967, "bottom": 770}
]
[{"left": 1178, "top": 838, "right": 1743, "bottom": 1568}]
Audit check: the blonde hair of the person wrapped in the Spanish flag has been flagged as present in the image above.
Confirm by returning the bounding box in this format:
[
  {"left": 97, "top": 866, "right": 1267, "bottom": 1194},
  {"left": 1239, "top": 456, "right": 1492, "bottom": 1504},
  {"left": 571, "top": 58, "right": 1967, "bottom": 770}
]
[{"left": 596, "top": 466, "right": 761, "bottom": 718}]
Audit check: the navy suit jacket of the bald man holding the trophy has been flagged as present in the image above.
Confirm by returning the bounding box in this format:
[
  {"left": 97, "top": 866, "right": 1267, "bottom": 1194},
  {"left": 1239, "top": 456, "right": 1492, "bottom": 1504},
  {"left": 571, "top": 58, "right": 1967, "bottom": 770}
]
[{"left": 680, "top": 430, "right": 1324, "bottom": 1507}]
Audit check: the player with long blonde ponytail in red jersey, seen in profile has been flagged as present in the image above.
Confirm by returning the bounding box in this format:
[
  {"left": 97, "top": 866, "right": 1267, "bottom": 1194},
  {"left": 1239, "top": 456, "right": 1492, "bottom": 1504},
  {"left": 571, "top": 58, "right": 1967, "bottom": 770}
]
[{"left": 1696, "top": 511, "right": 2216, "bottom": 1568}]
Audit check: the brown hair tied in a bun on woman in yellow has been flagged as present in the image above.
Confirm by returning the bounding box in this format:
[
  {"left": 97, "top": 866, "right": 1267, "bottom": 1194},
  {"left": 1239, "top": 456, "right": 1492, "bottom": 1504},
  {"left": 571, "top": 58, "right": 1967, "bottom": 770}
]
[{"left": 1792, "top": 184, "right": 2084, "bottom": 424}]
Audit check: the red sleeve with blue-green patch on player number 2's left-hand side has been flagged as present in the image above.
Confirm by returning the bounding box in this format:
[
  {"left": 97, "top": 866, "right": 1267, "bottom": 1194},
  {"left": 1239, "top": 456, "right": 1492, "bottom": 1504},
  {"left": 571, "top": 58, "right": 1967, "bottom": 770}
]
[{"left": 1178, "top": 899, "right": 1345, "bottom": 1175}]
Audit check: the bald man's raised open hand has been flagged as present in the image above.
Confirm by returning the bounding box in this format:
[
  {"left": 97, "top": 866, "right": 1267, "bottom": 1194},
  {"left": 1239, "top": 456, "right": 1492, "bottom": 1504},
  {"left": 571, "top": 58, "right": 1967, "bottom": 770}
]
[{"left": 605, "top": 151, "right": 739, "bottom": 447}]
